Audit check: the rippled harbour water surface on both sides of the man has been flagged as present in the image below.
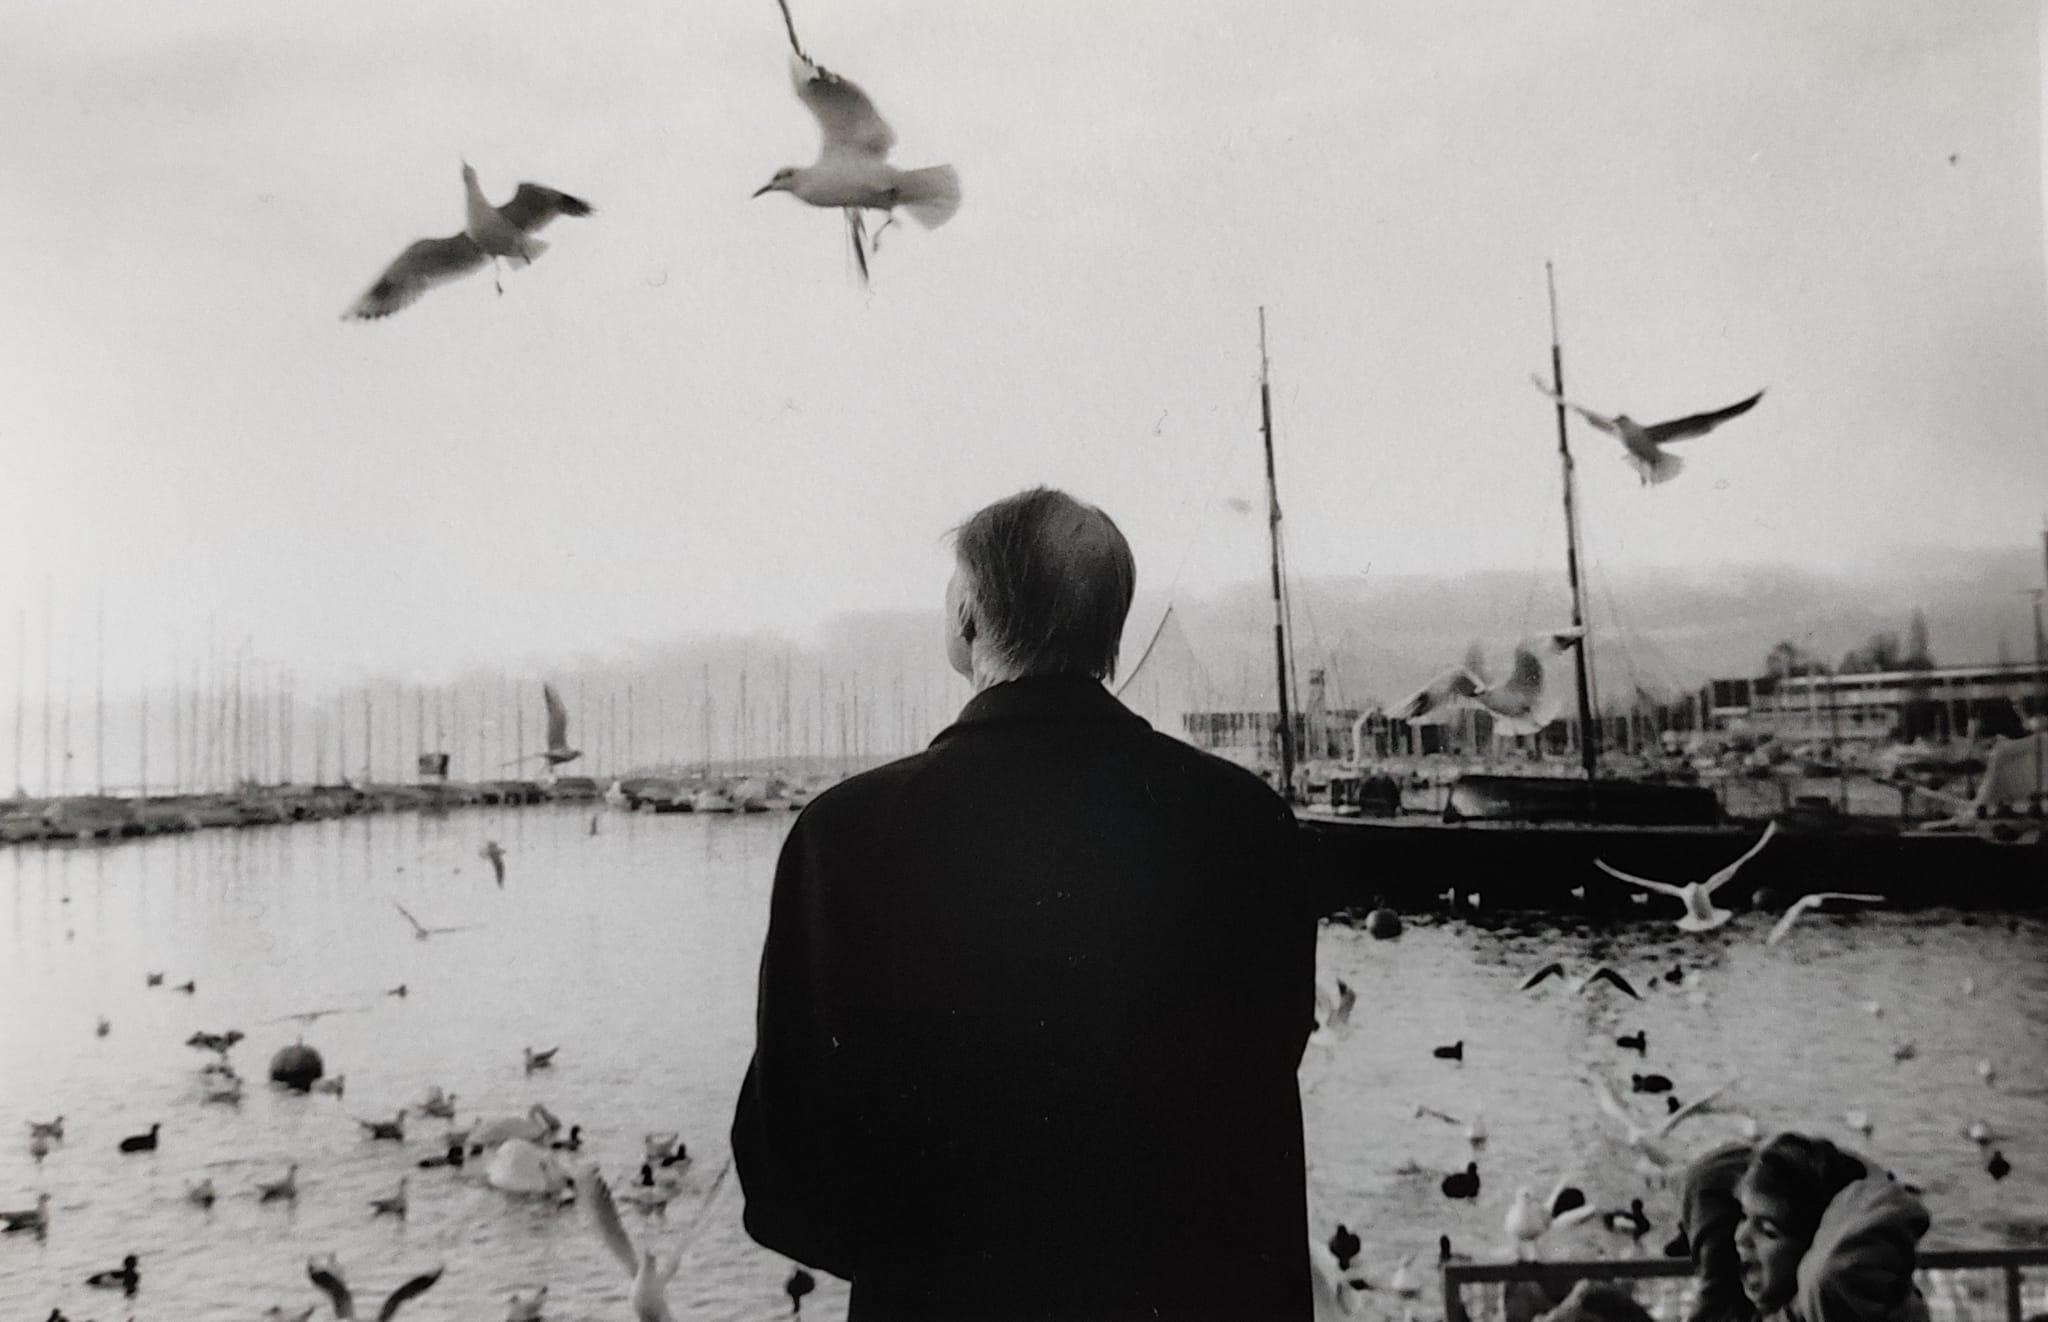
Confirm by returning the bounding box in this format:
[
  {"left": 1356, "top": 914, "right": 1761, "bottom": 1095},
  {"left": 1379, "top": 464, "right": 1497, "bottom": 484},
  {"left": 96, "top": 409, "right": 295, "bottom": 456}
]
[{"left": 0, "top": 808, "right": 2048, "bottom": 1322}]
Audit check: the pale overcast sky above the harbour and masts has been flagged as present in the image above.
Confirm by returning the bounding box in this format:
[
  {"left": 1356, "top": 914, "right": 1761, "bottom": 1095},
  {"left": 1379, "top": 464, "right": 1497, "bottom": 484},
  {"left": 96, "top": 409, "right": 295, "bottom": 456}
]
[{"left": 0, "top": 0, "right": 2048, "bottom": 692}]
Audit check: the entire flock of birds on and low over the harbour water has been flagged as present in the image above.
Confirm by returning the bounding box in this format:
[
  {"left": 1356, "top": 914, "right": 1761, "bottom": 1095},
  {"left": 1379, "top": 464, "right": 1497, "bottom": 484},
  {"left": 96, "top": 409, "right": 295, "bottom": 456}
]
[{"left": 0, "top": 736, "right": 2011, "bottom": 1322}]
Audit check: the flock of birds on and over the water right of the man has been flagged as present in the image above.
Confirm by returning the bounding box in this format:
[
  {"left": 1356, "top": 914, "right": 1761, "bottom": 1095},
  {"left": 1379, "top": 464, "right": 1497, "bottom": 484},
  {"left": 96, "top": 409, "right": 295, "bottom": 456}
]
[{"left": 1303, "top": 839, "right": 2013, "bottom": 1322}]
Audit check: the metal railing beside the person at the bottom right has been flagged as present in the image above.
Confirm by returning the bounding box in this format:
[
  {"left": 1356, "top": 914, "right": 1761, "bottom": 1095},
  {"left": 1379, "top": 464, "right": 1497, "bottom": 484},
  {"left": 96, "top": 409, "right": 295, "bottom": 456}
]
[{"left": 1444, "top": 1248, "right": 2048, "bottom": 1322}]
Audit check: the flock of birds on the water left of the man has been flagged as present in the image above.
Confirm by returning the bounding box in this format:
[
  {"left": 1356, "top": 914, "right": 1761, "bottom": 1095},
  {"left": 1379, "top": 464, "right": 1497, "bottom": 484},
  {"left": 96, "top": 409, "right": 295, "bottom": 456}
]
[{"left": 0, "top": 814, "right": 817, "bottom": 1322}]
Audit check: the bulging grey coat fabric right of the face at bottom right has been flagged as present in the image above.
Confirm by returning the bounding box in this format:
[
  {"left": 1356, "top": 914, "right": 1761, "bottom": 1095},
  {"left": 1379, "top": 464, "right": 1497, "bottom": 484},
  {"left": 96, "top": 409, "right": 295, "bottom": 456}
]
[{"left": 1792, "top": 1175, "right": 1927, "bottom": 1322}]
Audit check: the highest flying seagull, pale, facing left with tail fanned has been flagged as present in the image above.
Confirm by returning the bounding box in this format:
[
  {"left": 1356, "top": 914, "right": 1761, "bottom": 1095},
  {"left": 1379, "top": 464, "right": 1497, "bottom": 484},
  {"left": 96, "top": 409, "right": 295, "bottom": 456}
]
[{"left": 754, "top": 55, "right": 961, "bottom": 284}]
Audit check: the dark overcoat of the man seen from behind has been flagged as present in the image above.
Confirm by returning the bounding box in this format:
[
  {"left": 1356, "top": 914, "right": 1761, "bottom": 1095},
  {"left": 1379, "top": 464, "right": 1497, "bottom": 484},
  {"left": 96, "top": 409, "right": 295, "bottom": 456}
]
[{"left": 733, "top": 675, "right": 1315, "bottom": 1322}]
